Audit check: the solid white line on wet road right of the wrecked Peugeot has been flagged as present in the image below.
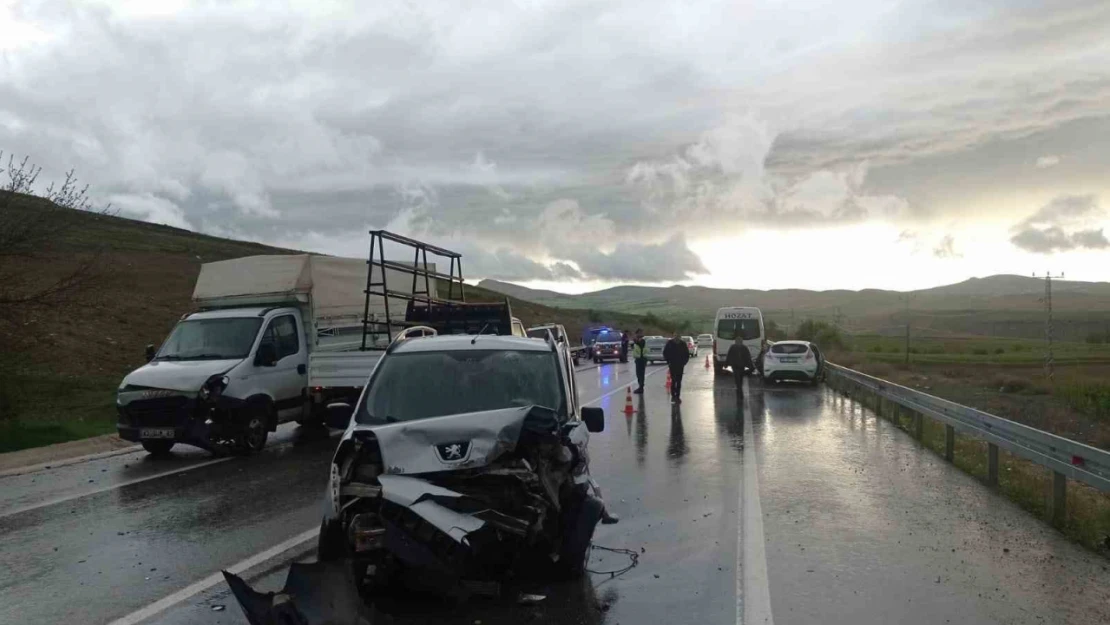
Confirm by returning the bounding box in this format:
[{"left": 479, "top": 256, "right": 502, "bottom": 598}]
[{"left": 736, "top": 384, "right": 775, "bottom": 625}]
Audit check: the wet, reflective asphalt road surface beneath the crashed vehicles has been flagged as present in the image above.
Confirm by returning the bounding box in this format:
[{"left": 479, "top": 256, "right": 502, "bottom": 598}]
[{"left": 0, "top": 362, "right": 1110, "bottom": 624}]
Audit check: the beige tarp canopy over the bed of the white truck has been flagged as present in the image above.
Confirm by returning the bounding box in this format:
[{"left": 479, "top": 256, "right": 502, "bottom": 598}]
[{"left": 193, "top": 254, "right": 436, "bottom": 329}]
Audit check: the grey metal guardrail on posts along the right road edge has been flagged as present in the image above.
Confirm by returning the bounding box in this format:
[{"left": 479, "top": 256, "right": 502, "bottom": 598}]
[{"left": 826, "top": 363, "right": 1110, "bottom": 503}]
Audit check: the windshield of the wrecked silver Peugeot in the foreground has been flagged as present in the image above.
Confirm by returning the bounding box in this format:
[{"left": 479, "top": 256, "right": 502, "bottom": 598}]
[{"left": 355, "top": 350, "right": 566, "bottom": 424}]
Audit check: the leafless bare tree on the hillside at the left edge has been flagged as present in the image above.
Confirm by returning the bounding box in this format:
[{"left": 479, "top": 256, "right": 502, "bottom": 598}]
[{"left": 0, "top": 151, "right": 111, "bottom": 317}]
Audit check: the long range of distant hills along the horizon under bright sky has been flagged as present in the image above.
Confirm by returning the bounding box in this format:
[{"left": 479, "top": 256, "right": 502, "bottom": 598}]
[{"left": 480, "top": 275, "right": 1110, "bottom": 341}]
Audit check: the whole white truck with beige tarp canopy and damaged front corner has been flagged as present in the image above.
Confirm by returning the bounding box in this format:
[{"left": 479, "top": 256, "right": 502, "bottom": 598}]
[{"left": 117, "top": 254, "right": 435, "bottom": 454}]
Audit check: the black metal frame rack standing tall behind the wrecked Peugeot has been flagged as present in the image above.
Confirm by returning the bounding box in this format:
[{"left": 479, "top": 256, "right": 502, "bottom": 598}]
[{"left": 361, "top": 230, "right": 466, "bottom": 351}]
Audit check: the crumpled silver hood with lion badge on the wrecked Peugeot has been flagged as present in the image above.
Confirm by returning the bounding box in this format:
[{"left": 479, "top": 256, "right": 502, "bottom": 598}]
[{"left": 346, "top": 406, "right": 559, "bottom": 475}]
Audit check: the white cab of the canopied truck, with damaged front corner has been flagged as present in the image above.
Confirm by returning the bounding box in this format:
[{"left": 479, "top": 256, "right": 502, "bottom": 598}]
[{"left": 117, "top": 306, "right": 310, "bottom": 454}]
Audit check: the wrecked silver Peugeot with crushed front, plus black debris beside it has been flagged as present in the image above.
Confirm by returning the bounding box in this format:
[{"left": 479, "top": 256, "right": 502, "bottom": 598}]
[{"left": 229, "top": 335, "right": 616, "bottom": 624}]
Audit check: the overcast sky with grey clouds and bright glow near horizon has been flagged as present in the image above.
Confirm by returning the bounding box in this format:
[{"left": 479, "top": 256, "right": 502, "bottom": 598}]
[{"left": 0, "top": 0, "right": 1110, "bottom": 291}]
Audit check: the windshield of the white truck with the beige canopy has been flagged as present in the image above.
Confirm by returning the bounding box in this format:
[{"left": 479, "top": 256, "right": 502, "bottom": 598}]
[{"left": 155, "top": 316, "right": 262, "bottom": 360}]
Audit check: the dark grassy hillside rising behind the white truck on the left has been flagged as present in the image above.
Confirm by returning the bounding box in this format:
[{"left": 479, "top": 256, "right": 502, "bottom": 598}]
[{"left": 0, "top": 196, "right": 659, "bottom": 452}]
